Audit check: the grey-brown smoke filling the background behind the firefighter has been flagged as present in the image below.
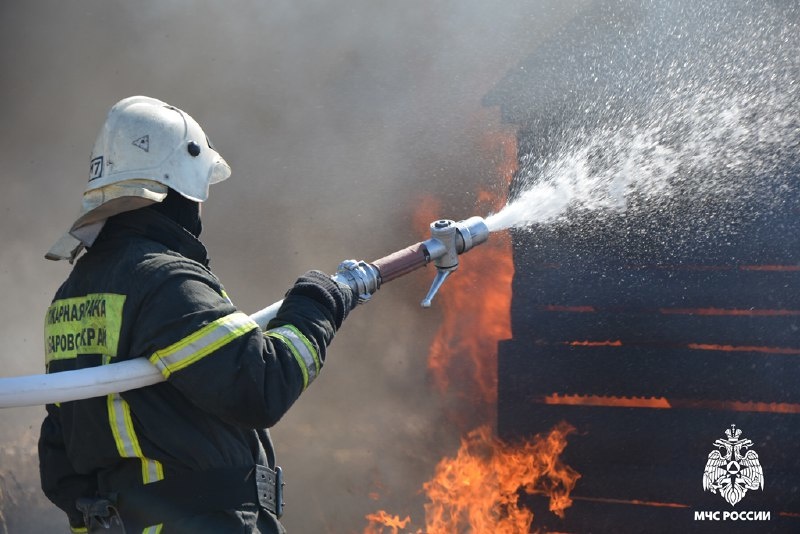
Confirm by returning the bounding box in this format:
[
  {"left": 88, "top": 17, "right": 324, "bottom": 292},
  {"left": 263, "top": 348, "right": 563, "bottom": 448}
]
[{"left": 0, "top": 0, "right": 585, "bottom": 532}]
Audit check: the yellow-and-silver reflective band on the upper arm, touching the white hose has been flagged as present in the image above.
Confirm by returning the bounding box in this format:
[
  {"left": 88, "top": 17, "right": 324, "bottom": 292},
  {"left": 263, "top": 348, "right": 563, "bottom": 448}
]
[{"left": 150, "top": 312, "right": 258, "bottom": 378}]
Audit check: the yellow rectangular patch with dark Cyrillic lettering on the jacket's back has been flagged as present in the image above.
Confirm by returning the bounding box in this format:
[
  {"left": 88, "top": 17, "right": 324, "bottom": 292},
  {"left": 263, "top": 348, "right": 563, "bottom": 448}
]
[{"left": 44, "top": 293, "right": 125, "bottom": 365}]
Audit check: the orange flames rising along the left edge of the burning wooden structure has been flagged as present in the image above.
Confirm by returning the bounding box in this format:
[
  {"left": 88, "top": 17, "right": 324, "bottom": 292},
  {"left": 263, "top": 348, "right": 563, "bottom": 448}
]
[{"left": 365, "top": 119, "right": 580, "bottom": 534}]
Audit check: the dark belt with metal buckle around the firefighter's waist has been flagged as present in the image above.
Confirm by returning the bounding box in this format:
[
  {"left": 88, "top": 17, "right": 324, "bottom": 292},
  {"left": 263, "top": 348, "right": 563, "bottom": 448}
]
[{"left": 104, "top": 465, "right": 285, "bottom": 528}]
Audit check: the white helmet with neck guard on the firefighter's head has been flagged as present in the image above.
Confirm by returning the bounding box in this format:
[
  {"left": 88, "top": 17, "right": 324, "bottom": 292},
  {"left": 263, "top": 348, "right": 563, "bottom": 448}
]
[{"left": 45, "top": 96, "right": 231, "bottom": 260}]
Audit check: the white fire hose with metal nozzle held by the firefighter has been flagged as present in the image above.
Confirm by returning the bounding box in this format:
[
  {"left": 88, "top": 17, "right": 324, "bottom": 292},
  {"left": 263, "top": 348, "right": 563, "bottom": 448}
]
[{"left": 0, "top": 217, "right": 489, "bottom": 408}]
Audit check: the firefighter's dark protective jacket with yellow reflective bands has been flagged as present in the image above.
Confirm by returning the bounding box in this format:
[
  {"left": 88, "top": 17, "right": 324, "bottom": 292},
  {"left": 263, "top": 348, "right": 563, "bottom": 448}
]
[{"left": 39, "top": 208, "right": 352, "bottom": 534}]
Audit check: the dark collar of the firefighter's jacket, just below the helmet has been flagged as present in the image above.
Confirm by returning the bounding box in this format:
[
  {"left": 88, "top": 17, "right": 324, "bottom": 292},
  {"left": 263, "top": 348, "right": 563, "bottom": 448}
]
[{"left": 93, "top": 208, "right": 209, "bottom": 267}]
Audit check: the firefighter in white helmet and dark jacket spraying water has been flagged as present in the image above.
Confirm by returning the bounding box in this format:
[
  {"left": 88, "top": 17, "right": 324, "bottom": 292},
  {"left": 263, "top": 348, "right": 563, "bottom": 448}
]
[{"left": 39, "top": 96, "right": 357, "bottom": 534}]
